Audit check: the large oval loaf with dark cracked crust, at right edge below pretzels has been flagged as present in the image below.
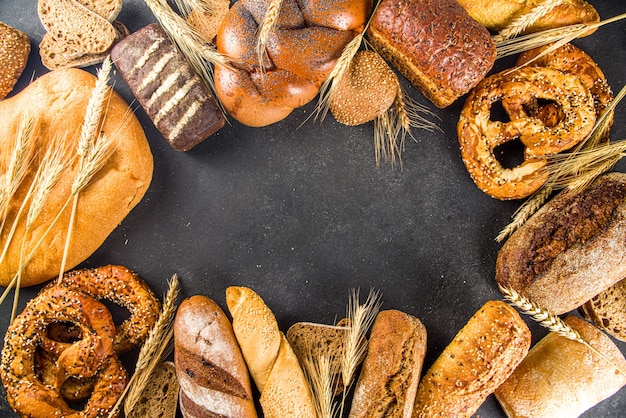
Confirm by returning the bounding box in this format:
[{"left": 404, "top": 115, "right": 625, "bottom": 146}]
[{"left": 496, "top": 173, "right": 626, "bottom": 315}]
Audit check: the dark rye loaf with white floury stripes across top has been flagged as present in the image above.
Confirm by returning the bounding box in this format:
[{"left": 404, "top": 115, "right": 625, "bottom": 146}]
[{"left": 111, "top": 23, "right": 225, "bottom": 151}]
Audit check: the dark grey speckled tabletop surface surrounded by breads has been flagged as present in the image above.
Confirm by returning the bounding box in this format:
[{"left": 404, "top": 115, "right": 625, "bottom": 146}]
[{"left": 0, "top": 0, "right": 626, "bottom": 418}]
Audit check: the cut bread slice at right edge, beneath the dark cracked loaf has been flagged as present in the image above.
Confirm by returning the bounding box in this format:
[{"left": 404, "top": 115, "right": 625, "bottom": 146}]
[{"left": 580, "top": 279, "right": 626, "bottom": 341}]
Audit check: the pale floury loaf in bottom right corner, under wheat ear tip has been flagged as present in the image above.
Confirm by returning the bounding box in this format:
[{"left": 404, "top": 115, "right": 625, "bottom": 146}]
[{"left": 495, "top": 316, "right": 626, "bottom": 418}]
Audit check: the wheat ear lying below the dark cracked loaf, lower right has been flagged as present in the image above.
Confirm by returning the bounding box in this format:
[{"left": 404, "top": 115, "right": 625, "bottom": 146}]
[{"left": 498, "top": 285, "right": 626, "bottom": 375}]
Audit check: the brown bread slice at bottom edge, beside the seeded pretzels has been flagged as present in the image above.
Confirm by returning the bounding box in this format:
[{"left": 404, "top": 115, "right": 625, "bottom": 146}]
[{"left": 125, "top": 361, "right": 179, "bottom": 418}]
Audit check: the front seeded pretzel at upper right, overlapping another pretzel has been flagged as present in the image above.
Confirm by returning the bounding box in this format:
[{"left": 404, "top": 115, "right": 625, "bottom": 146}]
[{"left": 457, "top": 67, "right": 596, "bottom": 200}]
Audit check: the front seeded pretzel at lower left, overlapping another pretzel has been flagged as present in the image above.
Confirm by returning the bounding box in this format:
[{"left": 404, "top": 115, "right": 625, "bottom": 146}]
[{"left": 0, "top": 287, "right": 128, "bottom": 418}]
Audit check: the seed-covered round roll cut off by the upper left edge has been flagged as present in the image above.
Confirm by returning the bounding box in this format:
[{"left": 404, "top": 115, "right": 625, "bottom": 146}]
[{"left": 0, "top": 22, "right": 30, "bottom": 100}]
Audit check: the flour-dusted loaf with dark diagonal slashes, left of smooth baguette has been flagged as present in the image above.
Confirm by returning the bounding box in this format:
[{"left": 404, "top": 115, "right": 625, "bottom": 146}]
[{"left": 174, "top": 295, "right": 257, "bottom": 418}]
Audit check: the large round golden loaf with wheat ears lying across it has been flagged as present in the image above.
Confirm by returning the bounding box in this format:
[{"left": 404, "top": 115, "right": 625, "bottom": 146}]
[{"left": 0, "top": 68, "right": 153, "bottom": 286}]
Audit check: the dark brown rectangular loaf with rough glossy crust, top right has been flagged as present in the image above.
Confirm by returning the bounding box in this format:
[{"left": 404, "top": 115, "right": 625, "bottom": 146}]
[{"left": 367, "top": 0, "right": 496, "bottom": 108}]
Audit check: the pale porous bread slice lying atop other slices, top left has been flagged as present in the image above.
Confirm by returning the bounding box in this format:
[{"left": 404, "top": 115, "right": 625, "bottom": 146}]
[{"left": 37, "top": 0, "right": 116, "bottom": 54}]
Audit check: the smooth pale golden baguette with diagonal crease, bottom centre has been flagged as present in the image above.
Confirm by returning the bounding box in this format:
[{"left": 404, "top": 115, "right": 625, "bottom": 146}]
[{"left": 226, "top": 286, "right": 315, "bottom": 418}]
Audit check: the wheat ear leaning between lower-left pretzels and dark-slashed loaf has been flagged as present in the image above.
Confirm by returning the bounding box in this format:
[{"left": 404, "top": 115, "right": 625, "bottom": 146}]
[{"left": 109, "top": 274, "right": 179, "bottom": 418}]
